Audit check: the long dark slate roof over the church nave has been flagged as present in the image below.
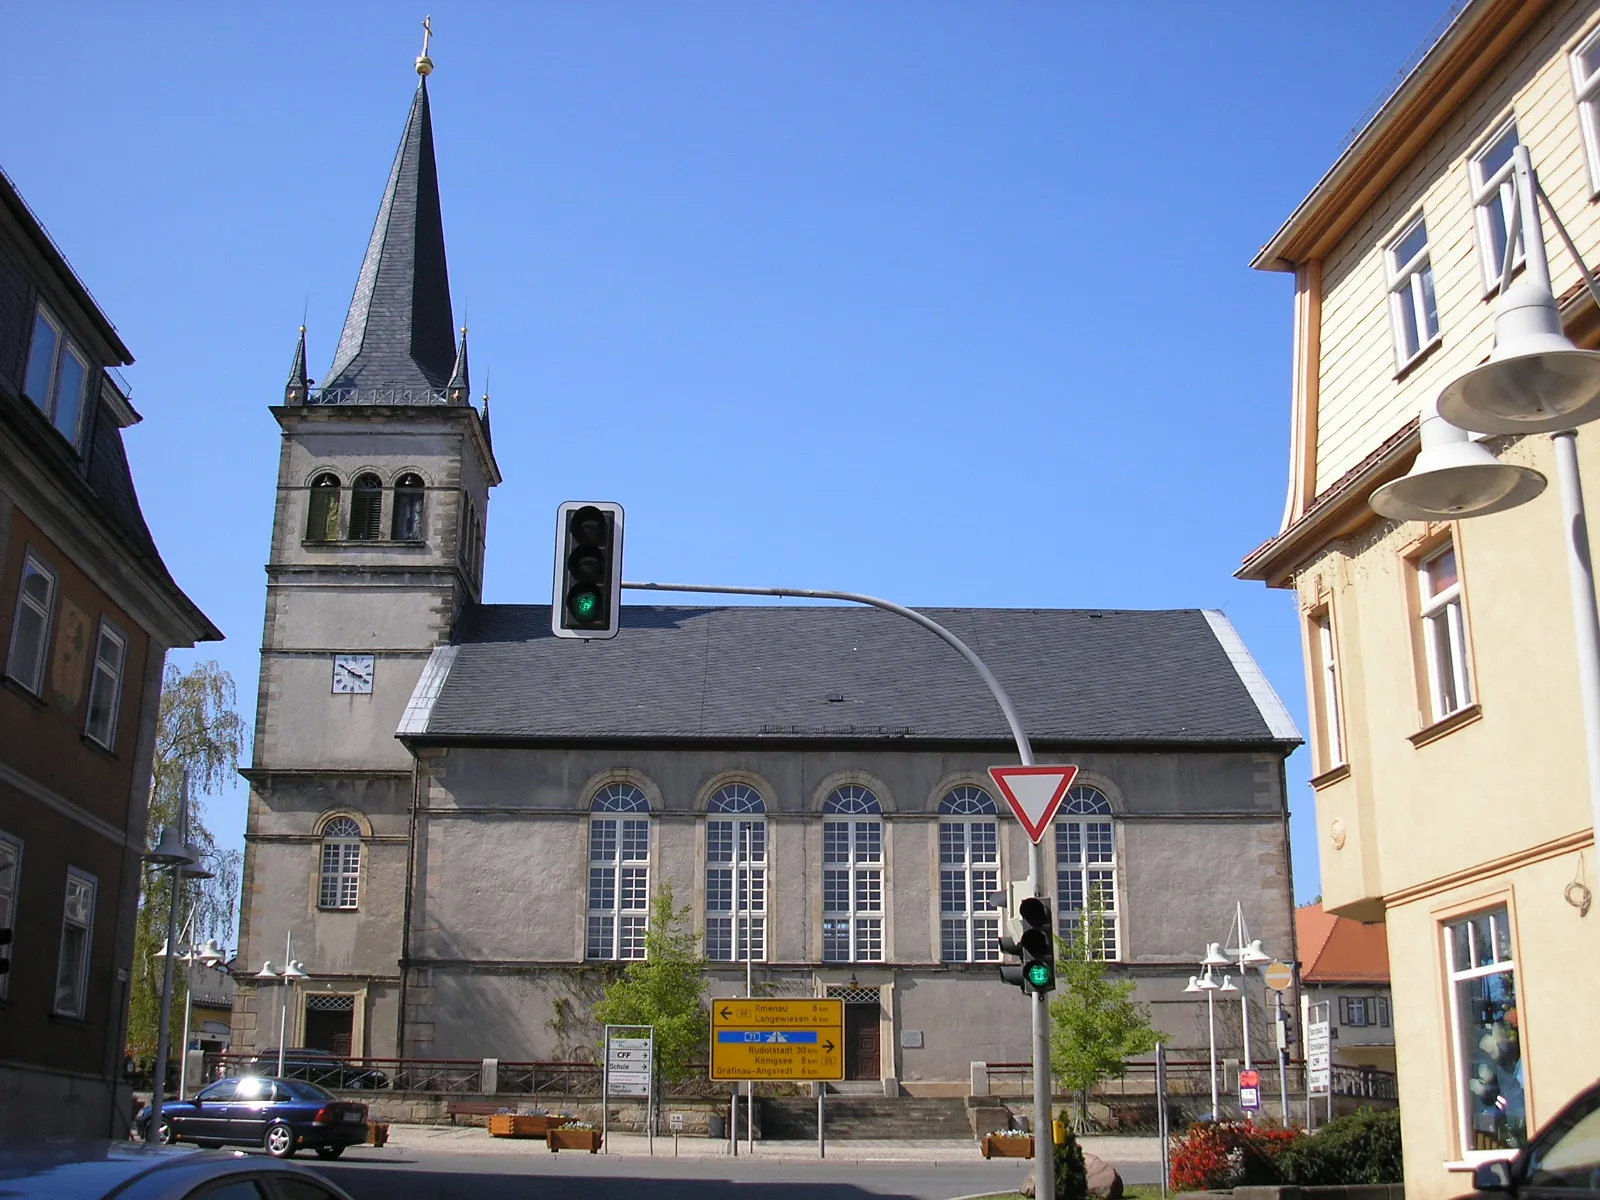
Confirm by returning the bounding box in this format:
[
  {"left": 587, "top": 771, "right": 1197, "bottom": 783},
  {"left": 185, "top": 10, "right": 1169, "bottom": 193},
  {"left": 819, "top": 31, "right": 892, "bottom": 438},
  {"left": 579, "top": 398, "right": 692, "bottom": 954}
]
[{"left": 400, "top": 605, "right": 1299, "bottom": 749}]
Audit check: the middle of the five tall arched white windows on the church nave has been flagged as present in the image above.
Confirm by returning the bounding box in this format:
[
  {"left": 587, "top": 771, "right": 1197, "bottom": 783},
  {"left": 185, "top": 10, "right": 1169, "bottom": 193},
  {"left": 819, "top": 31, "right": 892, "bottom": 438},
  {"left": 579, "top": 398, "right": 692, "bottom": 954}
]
[{"left": 822, "top": 784, "right": 886, "bottom": 963}]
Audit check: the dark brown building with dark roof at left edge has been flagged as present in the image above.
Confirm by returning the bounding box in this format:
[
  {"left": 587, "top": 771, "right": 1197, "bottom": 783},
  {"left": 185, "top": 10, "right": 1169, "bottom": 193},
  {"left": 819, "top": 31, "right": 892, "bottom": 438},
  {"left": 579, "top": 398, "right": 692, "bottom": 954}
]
[{"left": 0, "top": 173, "right": 221, "bottom": 1136}]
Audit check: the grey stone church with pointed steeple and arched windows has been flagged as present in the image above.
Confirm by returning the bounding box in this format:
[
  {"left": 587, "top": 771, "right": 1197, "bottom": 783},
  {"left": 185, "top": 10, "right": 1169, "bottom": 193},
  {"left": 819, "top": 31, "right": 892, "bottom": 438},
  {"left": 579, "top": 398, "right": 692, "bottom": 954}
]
[{"left": 232, "top": 58, "right": 1299, "bottom": 1096}]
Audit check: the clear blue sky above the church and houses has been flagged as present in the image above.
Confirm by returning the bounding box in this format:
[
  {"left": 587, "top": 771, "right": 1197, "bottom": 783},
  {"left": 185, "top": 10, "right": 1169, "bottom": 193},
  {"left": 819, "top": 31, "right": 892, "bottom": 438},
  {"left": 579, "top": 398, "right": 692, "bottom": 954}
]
[{"left": 0, "top": 0, "right": 1446, "bottom": 928}]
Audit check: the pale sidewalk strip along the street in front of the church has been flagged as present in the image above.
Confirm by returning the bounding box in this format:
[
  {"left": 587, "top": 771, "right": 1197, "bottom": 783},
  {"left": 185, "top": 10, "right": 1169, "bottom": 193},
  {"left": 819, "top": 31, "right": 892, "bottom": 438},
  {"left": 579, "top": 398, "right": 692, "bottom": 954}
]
[{"left": 379, "top": 1125, "right": 1162, "bottom": 1166}]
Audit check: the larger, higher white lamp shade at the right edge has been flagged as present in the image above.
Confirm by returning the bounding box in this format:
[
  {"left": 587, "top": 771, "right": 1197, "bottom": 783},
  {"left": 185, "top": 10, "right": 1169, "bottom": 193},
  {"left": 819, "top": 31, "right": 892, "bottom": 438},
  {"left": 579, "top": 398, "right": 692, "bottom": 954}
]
[{"left": 1438, "top": 275, "right": 1600, "bottom": 434}]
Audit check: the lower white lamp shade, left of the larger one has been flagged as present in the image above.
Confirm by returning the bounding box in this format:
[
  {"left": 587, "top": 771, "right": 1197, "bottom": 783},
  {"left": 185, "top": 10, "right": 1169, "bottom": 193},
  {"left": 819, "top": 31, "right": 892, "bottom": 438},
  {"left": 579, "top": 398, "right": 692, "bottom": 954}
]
[{"left": 1371, "top": 404, "right": 1542, "bottom": 522}]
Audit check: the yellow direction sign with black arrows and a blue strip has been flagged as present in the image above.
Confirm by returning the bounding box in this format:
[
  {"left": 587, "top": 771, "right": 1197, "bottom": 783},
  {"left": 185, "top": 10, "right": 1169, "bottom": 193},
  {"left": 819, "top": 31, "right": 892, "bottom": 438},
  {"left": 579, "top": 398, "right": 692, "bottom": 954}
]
[{"left": 710, "top": 1000, "right": 845, "bottom": 1080}]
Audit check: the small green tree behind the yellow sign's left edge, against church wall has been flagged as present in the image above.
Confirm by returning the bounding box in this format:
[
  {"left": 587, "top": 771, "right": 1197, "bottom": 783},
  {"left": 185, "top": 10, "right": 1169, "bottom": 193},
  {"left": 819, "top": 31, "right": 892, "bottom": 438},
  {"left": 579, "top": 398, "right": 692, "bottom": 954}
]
[{"left": 594, "top": 883, "right": 710, "bottom": 1082}]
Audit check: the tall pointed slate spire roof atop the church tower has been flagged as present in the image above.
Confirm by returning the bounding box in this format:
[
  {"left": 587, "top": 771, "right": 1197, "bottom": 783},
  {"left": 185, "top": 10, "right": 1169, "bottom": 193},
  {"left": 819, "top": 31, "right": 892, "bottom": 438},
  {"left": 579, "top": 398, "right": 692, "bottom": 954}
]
[{"left": 322, "top": 78, "right": 456, "bottom": 392}]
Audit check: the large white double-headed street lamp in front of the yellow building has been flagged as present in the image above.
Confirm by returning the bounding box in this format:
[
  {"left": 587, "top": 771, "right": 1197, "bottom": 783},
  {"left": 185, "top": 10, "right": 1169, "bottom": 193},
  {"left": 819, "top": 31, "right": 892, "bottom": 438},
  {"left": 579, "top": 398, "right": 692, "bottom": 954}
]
[{"left": 1371, "top": 146, "right": 1600, "bottom": 864}]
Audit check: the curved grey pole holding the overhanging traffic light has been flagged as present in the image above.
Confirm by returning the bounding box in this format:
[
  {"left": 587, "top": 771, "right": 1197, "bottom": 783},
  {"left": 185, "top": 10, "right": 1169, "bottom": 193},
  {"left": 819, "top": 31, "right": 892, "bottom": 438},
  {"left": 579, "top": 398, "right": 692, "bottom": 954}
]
[{"left": 622, "top": 581, "right": 1056, "bottom": 1200}]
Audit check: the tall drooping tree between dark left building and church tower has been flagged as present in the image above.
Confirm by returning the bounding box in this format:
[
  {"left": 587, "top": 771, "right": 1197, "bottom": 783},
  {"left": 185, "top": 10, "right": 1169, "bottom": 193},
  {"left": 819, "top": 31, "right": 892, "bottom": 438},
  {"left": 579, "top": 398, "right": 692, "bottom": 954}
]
[{"left": 128, "top": 661, "right": 246, "bottom": 1061}]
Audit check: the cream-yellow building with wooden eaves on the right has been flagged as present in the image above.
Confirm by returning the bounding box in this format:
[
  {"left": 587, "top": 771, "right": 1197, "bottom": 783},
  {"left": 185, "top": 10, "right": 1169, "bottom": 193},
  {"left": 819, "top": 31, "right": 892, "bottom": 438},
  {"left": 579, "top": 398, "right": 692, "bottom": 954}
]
[{"left": 1240, "top": 0, "right": 1600, "bottom": 1198}]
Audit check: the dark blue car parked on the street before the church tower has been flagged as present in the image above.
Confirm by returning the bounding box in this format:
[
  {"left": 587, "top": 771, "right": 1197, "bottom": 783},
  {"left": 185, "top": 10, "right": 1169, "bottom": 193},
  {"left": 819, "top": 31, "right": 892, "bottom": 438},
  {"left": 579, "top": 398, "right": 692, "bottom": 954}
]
[{"left": 138, "top": 1075, "right": 366, "bottom": 1158}]
